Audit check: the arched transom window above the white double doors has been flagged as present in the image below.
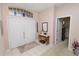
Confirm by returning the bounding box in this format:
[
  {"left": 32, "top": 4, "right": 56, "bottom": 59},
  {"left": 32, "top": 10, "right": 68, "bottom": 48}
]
[{"left": 9, "top": 8, "right": 33, "bottom": 18}]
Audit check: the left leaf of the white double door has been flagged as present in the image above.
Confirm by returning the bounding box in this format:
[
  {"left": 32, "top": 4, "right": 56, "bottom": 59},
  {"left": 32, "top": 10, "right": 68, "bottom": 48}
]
[{"left": 8, "top": 17, "right": 25, "bottom": 48}]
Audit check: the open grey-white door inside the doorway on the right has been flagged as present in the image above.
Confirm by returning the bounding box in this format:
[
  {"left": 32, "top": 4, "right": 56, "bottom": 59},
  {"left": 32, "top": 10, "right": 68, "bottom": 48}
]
[{"left": 56, "top": 19, "right": 62, "bottom": 44}]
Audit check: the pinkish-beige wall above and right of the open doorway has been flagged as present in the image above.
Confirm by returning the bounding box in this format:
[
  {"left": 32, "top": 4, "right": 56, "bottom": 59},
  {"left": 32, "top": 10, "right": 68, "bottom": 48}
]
[{"left": 56, "top": 4, "right": 79, "bottom": 50}]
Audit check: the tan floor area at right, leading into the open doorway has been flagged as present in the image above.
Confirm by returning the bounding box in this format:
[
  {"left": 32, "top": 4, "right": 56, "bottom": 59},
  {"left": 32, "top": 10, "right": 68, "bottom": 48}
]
[{"left": 42, "top": 40, "right": 74, "bottom": 56}]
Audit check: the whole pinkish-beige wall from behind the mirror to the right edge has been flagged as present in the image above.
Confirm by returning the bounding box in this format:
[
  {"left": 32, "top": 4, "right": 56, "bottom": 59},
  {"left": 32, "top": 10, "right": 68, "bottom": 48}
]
[{"left": 38, "top": 4, "right": 79, "bottom": 50}]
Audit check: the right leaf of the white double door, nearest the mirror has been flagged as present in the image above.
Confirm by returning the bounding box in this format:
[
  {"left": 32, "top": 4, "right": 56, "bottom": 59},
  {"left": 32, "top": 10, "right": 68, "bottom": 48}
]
[{"left": 25, "top": 18, "right": 36, "bottom": 43}]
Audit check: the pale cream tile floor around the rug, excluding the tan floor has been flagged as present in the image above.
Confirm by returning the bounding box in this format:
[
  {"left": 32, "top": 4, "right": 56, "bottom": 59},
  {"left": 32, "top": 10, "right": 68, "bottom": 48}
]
[{"left": 4, "top": 43, "right": 50, "bottom": 56}]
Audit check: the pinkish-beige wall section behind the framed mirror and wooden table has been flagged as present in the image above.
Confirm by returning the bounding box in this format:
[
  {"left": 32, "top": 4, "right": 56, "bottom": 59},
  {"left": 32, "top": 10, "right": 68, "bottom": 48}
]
[{"left": 38, "top": 6, "right": 55, "bottom": 45}]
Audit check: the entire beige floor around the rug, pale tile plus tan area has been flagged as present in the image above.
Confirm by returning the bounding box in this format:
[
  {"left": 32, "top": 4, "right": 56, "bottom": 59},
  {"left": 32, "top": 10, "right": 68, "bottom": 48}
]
[{"left": 5, "top": 41, "right": 73, "bottom": 56}]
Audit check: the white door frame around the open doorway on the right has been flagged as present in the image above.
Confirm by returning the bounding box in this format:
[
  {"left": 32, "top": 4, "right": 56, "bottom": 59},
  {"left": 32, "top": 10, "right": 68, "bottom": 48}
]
[{"left": 55, "top": 15, "right": 71, "bottom": 46}]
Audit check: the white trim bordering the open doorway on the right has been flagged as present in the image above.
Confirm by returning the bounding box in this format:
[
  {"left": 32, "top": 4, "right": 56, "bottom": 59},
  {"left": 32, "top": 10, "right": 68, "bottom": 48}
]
[{"left": 55, "top": 15, "right": 72, "bottom": 48}]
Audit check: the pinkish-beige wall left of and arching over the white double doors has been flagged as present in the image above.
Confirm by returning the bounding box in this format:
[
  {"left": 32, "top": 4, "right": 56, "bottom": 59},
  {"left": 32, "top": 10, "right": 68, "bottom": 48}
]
[{"left": 0, "top": 4, "right": 38, "bottom": 54}]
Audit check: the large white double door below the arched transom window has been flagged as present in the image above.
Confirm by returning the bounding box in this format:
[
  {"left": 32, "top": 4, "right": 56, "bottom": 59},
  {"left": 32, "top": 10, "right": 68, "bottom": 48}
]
[{"left": 8, "top": 17, "right": 36, "bottom": 48}]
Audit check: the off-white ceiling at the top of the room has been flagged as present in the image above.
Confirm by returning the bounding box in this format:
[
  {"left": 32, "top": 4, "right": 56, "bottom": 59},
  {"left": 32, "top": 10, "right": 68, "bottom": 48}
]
[{"left": 14, "top": 3, "right": 64, "bottom": 12}]
